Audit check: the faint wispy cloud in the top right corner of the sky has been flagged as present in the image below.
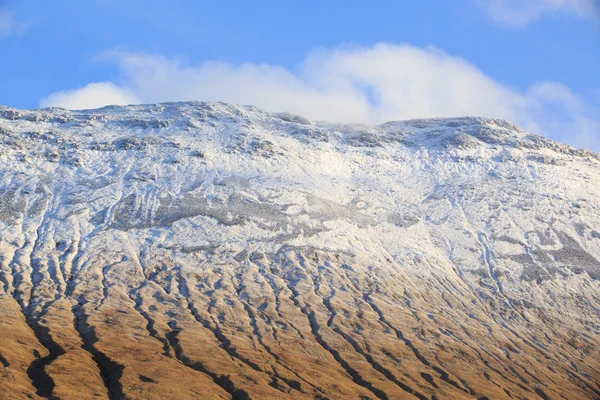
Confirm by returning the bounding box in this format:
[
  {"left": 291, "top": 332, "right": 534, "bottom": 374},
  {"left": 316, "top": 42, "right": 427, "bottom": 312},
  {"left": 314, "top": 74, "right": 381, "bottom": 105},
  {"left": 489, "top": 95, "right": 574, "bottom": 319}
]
[{"left": 477, "top": 0, "right": 598, "bottom": 27}]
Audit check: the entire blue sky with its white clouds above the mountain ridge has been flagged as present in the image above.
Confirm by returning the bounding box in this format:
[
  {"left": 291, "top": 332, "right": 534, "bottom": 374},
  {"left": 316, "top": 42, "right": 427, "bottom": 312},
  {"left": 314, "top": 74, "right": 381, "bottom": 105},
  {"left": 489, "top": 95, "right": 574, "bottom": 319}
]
[{"left": 0, "top": 0, "right": 600, "bottom": 151}]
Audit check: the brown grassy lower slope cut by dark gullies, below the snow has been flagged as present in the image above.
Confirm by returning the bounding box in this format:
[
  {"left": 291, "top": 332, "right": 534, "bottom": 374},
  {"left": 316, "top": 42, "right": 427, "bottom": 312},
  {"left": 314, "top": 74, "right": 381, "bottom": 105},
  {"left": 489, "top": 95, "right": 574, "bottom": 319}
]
[{"left": 0, "top": 252, "right": 600, "bottom": 399}]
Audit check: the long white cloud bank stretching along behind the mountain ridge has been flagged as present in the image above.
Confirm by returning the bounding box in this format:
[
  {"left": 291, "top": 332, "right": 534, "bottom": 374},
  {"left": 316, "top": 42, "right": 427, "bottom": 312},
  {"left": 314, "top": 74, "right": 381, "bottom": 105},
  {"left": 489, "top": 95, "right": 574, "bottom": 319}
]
[{"left": 41, "top": 44, "right": 600, "bottom": 149}]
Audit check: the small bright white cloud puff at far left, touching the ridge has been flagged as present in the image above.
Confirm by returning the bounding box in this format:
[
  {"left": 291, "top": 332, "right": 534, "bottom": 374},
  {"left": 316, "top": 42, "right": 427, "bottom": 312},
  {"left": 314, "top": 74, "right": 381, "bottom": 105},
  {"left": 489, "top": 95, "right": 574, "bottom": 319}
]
[{"left": 40, "top": 82, "right": 140, "bottom": 109}]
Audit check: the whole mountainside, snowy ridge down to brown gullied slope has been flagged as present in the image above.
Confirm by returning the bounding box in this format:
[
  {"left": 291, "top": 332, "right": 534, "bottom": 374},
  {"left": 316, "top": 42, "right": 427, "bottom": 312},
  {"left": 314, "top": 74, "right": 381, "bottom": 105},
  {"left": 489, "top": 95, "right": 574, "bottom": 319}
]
[{"left": 0, "top": 103, "right": 600, "bottom": 400}]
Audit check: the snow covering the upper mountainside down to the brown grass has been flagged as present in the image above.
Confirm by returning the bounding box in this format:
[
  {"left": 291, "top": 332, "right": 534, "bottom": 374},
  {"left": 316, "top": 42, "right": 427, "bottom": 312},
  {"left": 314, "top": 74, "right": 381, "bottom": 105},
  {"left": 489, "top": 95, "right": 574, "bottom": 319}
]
[{"left": 0, "top": 102, "right": 600, "bottom": 396}]
